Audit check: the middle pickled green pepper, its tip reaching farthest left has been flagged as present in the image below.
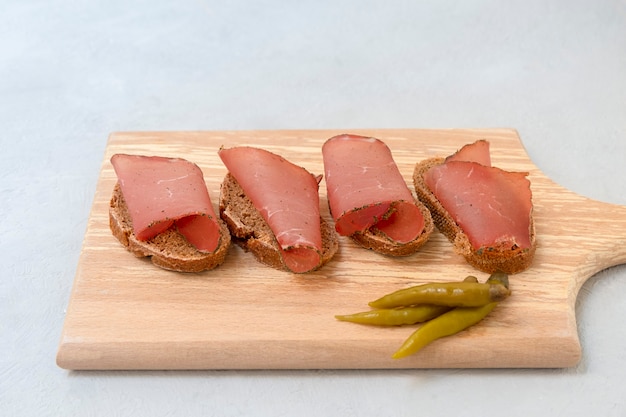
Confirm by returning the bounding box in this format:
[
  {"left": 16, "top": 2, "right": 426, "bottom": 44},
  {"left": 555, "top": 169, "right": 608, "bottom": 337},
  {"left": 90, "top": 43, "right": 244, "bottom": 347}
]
[{"left": 335, "top": 275, "right": 478, "bottom": 326}]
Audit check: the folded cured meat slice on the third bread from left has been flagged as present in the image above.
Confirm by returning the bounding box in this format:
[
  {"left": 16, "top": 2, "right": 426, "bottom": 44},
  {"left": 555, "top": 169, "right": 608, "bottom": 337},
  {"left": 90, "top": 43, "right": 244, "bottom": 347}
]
[{"left": 322, "top": 135, "right": 425, "bottom": 243}]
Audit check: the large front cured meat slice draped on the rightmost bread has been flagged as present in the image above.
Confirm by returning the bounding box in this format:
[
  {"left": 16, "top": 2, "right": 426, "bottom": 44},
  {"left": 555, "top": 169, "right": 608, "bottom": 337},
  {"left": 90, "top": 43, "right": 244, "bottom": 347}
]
[{"left": 424, "top": 160, "right": 532, "bottom": 250}]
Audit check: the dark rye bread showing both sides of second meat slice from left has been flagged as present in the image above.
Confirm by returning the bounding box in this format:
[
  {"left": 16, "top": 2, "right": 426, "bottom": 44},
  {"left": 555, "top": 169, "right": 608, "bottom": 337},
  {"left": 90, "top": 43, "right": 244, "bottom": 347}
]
[{"left": 219, "top": 173, "right": 339, "bottom": 272}]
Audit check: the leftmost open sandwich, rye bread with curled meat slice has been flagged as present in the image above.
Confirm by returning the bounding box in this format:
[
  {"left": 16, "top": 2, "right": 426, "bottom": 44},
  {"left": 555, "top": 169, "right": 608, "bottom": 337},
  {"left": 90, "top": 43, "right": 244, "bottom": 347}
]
[{"left": 109, "top": 154, "right": 231, "bottom": 272}]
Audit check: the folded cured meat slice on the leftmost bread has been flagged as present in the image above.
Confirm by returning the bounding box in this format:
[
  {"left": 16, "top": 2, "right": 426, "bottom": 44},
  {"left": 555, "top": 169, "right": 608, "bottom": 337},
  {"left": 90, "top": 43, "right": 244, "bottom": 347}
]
[{"left": 111, "top": 154, "right": 220, "bottom": 253}]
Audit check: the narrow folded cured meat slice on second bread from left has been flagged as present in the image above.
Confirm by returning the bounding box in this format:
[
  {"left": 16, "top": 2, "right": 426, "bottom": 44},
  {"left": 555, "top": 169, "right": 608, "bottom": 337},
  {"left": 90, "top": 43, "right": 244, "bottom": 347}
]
[{"left": 218, "top": 146, "right": 322, "bottom": 273}]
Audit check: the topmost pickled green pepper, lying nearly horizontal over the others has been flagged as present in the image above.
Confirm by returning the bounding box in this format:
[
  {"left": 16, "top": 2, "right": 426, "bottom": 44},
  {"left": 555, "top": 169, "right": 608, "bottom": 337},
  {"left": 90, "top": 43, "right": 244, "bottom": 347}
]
[{"left": 369, "top": 281, "right": 511, "bottom": 308}]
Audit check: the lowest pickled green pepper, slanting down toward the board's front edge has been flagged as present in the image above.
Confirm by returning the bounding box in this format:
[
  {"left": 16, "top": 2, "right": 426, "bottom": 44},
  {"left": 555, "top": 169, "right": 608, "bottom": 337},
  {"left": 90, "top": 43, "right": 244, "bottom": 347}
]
[{"left": 392, "top": 302, "right": 498, "bottom": 359}]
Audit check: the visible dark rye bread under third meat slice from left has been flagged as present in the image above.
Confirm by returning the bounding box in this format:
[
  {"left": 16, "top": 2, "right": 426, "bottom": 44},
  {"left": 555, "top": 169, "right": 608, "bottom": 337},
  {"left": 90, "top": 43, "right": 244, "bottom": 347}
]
[{"left": 350, "top": 200, "right": 435, "bottom": 256}]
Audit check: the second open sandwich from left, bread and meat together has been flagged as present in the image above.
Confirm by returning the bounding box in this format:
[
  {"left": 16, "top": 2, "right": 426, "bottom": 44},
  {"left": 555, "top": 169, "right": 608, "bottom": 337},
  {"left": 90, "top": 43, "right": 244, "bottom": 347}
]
[{"left": 218, "top": 146, "right": 339, "bottom": 274}]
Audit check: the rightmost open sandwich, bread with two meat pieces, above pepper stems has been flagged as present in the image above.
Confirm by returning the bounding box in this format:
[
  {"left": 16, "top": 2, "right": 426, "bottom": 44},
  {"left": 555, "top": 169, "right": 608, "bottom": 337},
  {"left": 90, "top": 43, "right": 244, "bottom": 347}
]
[{"left": 413, "top": 140, "right": 537, "bottom": 274}]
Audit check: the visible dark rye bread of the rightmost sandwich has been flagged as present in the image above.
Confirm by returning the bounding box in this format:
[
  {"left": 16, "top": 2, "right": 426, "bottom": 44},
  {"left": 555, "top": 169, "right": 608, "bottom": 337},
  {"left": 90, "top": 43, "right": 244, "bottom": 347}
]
[{"left": 413, "top": 158, "right": 537, "bottom": 274}]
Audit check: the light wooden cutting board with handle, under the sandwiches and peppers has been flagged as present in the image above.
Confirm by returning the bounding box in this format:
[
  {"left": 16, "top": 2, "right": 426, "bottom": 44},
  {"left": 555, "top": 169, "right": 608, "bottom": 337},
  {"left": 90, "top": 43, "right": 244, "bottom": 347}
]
[{"left": 57, "top": 129, "right": 626, "bottom": 370}]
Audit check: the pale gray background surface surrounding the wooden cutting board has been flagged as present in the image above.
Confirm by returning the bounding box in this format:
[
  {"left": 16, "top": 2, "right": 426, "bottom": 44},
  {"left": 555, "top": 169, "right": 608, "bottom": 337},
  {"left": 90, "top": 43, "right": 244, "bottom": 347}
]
[{"left": 0, "top": 0, "right": 626, "bottom": 416}]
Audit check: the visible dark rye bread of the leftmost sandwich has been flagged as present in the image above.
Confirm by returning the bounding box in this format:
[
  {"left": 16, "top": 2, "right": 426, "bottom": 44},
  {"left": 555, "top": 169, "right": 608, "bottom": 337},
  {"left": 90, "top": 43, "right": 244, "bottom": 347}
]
[{"left": 109, "top": 183, "right": 231, "bottom": 272}]
